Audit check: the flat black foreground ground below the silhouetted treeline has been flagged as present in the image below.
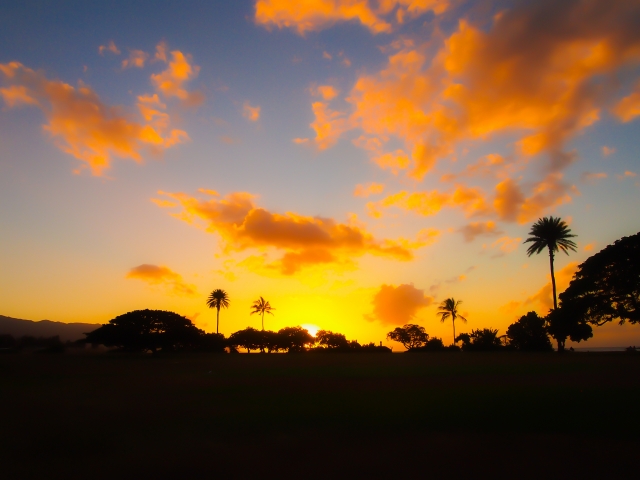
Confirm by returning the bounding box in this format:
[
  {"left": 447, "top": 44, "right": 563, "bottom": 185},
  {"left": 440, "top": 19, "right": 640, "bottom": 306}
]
[{"left": 0, "top": 353, "right": 640, "bottom": 479}]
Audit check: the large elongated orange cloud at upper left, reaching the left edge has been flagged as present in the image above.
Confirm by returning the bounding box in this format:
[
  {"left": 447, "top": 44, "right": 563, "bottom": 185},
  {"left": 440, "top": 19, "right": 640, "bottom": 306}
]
[{"left": 0, "top": 62, "right": 188, "bottom": 175}]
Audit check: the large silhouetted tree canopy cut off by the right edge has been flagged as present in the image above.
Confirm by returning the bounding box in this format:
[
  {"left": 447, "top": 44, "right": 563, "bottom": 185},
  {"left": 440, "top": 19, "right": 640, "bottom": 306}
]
[{"left": 560, "top": 233, "right": 640, "bottom": 325}]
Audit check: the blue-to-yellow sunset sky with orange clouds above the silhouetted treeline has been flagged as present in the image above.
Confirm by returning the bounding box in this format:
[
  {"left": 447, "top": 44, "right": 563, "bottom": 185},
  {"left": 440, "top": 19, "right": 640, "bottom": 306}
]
[{"left": 0, "top": 0, "right": 640, "bottom": 350}]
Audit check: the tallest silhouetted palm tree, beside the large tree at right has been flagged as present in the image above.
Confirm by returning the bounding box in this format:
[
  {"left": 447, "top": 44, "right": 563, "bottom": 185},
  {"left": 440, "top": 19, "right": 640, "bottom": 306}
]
[{"left": 523, "top": 217, "right": 577, "bottom": 310}]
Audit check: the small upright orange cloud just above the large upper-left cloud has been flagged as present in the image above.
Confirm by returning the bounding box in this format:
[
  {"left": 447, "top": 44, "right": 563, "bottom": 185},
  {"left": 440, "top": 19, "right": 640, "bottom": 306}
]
[{"left": 151, "top": 43, "right": 204, "bottom": 105}]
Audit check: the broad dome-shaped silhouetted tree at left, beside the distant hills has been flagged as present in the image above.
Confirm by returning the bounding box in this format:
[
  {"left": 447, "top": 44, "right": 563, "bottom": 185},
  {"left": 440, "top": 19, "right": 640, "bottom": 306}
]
[{"left": 85, "top": 310, "right": 204, "bottom": 352}]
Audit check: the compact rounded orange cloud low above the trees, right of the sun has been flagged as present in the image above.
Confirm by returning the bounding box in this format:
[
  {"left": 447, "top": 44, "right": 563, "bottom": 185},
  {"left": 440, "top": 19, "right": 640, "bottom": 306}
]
[{"left": 365, "top": 284, "right": 433, "bottom": 325}]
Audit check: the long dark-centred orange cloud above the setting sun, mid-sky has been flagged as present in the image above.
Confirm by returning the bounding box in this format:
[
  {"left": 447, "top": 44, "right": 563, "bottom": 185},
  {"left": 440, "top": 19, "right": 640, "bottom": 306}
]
[{"left": 155, "top": 190, "right": 425, "bottom": 275}]
